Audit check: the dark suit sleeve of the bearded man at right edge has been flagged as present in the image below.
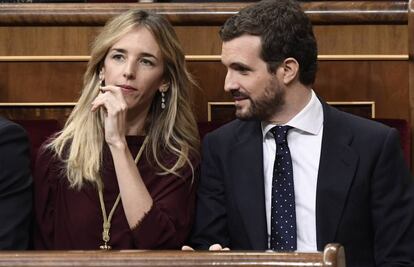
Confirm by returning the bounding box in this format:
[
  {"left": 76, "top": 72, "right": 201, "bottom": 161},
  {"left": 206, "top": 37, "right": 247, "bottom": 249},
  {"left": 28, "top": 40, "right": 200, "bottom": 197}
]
[{"left": 371, "top": 130, "right": 414, "bottom": 266}]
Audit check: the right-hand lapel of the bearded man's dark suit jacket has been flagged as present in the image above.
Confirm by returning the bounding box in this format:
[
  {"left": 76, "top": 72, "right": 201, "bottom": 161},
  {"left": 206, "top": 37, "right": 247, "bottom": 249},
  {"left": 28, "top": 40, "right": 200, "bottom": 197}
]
[{"left": 316, "top": 103, "right": 358, "bottom": 250}]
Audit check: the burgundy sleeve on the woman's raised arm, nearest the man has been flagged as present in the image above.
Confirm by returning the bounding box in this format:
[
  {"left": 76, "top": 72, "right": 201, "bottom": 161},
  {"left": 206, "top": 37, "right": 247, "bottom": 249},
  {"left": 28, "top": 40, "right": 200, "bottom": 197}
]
[{"left": 132, "top": 162, "right": 196, "bottom": 249}]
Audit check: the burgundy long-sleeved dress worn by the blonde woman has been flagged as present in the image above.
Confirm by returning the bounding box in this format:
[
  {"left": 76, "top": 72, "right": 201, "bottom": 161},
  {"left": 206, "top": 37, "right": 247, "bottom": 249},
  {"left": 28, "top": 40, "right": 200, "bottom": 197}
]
[{"left": 34, "top": 136, "right": 198, "bottom": 250}]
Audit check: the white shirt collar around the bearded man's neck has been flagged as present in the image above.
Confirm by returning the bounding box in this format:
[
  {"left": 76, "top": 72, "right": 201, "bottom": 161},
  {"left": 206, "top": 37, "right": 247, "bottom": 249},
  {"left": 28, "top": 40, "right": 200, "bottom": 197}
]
[{"left": 261, "top": 90, "right": 323, "bottom": 138}]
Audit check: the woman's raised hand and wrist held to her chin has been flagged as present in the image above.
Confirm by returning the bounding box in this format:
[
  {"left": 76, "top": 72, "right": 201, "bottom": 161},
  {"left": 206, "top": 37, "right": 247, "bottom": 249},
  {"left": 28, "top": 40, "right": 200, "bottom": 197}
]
[{"left": 91, "top": 85, "right": 127, "bottom": 147}]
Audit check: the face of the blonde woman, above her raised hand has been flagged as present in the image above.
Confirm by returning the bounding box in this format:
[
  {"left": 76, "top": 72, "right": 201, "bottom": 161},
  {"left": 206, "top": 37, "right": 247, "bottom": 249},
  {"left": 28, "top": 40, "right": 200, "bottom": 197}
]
[{"left": 102, "top": 26, "right": 164, "bottom": 111}]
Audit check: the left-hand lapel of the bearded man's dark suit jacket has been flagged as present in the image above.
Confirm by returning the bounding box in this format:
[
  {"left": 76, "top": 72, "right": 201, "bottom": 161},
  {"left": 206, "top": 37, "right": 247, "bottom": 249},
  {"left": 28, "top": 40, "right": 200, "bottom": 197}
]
[{"left": 229, "top": 122, "right": 267, "bottom": 250}]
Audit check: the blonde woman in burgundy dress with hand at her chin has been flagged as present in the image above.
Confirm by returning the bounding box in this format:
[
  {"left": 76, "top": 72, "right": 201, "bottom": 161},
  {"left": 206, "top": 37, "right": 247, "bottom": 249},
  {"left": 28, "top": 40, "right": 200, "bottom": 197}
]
[{"left": 35, "top": 10, "right": 199, "bottom": 249}]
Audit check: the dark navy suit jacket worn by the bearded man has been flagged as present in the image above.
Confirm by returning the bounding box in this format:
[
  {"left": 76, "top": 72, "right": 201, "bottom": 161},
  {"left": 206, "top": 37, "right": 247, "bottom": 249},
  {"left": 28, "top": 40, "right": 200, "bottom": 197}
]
[{"left": 191, "top": 104, "right": 414, "bottom": 266}]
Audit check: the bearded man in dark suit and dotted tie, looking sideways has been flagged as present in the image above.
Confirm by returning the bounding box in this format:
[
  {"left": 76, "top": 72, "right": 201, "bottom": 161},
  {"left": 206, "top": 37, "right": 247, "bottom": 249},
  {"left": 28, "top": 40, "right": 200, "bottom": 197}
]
[{"left": 183, "top": 0, "right": 414, "bottom": 266}]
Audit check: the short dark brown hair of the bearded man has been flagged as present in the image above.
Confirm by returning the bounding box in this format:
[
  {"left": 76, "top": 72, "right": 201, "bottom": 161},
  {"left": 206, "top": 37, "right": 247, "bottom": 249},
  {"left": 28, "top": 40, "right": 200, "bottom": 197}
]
[{"left": 220, "top": 0, "right": 318, "bottom": 85}]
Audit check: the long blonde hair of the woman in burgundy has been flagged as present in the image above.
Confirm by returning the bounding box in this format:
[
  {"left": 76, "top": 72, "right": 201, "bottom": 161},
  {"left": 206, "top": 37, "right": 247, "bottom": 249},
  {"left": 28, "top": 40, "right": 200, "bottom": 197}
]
[{"left": 47, "top": 10, "right": 200, "bottom": 189}]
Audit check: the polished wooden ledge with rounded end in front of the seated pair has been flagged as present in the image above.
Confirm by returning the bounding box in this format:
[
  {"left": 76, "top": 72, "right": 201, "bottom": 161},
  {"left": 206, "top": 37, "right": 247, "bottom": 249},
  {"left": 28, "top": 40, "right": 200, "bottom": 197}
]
[{"left": 0, "top": 244, "right": 345, "bottom": 267}]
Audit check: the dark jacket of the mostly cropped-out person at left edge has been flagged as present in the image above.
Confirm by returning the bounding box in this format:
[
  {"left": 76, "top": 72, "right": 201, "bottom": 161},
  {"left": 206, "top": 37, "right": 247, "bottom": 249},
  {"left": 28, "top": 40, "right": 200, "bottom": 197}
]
[{"left": 0, "top": 118, "right": 32, "bottom": 250}]
